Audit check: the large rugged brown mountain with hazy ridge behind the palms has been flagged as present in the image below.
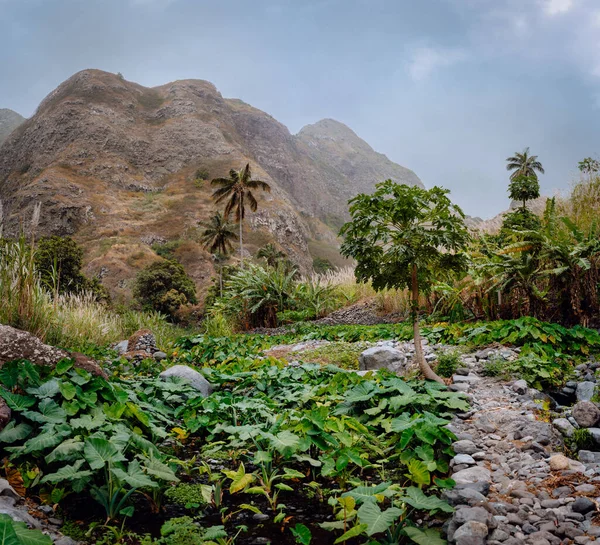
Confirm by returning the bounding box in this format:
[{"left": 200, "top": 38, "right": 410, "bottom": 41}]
[{"left": 0, "top": 70, "right": 420, "bottom": 298}]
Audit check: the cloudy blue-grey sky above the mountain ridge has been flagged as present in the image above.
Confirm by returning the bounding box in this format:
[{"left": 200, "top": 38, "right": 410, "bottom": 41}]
[{"left": 0, "top": 0, "right": 600, "bottom": 217}]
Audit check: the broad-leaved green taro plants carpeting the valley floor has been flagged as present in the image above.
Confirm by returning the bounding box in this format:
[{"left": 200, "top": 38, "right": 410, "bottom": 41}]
[{"left": 0, "top": 319, "right": 600, "bottom": 545}]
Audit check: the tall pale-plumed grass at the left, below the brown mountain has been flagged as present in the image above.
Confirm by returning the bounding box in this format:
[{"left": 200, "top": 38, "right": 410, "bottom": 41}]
[{"left": 0, "top": 237, "right": 186, "bottom": 349}]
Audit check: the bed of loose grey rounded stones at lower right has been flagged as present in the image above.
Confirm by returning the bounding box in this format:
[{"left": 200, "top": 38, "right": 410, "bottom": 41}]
[{"left": 445, "top": 365, "right": 600, "bottom": 545}]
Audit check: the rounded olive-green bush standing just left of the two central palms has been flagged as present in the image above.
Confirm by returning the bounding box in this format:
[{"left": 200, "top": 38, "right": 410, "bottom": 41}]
[{"left": 133, "top": 260, "right": 198, "bottom": 318}]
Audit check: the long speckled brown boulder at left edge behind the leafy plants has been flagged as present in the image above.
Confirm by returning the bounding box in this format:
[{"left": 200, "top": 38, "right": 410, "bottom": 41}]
[{"left": 0, "top": 325, "right": 106, "bottom": 378}]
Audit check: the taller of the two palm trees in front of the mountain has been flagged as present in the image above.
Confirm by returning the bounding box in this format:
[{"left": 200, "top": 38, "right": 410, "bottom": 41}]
[{"left": 211, "top": 164, "right": 271, "bottom": 263}]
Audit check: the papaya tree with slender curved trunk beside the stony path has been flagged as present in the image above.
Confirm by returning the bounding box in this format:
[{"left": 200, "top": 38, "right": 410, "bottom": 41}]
[{"left": 341, "top": 180, "right": 469, "bottom": 383}]
